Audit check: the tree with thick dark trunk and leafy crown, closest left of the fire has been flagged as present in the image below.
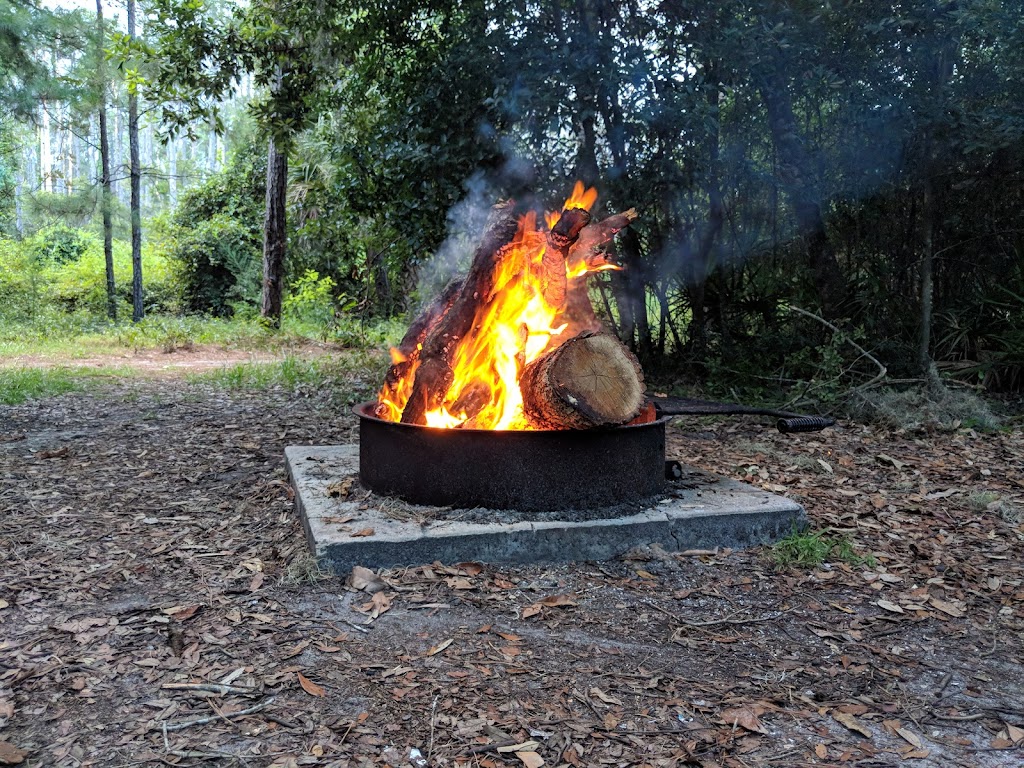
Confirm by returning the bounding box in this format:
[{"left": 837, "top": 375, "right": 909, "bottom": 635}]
[{"left": 138, "top": 0, "right": 348, "bottom": 327}]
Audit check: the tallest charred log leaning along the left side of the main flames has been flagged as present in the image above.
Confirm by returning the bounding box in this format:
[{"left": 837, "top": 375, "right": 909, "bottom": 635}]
[{"left": 401, "top": 202, "right": 518, "bottom": 424}]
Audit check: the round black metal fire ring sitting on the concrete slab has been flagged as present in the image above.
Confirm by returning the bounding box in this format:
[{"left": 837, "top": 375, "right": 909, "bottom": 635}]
[{"left": 355, "top": 402, "right": 668, "bottom": 511}]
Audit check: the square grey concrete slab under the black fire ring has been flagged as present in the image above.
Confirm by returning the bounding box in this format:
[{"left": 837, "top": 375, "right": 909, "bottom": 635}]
[{"left": 285, "top": 445, "right": 805, "bottom": 573}]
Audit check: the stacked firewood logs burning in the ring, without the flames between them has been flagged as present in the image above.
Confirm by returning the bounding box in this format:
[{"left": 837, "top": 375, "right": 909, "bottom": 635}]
[{"left": 377, "top": 195, "right": 644, "bottom": 429}]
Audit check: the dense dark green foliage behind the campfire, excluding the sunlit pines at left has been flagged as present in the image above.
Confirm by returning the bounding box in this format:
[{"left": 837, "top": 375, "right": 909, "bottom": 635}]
[{"left": 0, "top": 0, "right": 1024, "bottom": 397}]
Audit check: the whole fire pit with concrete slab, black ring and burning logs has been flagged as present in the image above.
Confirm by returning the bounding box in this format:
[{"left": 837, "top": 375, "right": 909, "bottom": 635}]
[{"left": 286, "top": 183, "right": 803, "bottom": 571}]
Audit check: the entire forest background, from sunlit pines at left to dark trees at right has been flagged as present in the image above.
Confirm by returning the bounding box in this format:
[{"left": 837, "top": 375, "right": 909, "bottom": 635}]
[{"left": 0, "top": 0, "right": 1024, "bottom": 417}]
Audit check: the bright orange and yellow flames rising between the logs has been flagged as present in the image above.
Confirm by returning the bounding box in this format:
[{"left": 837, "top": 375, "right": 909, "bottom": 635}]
[{"left": 378, "top": 181, "right": 618, "bottom": 429}]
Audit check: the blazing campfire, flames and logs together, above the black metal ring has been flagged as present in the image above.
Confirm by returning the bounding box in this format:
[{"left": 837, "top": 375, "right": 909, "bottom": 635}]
[{"left": 374, "top": 182, "right": 649, "bottom": 430}]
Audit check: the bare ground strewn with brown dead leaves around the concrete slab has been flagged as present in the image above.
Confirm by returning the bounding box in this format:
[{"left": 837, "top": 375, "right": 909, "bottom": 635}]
[{"left": 0, "top": 360, "right": 1024, "bottom": 768}]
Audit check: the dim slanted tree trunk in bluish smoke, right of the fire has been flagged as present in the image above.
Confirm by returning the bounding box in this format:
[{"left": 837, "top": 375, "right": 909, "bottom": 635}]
[{"left": 758, "top": 63, "right": 847, "bottom": 318}]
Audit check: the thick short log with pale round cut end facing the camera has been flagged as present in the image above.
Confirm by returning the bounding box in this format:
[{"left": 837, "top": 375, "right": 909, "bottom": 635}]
[{"left": 519, "top": 332, "right": 645, "bottom": 429}]
